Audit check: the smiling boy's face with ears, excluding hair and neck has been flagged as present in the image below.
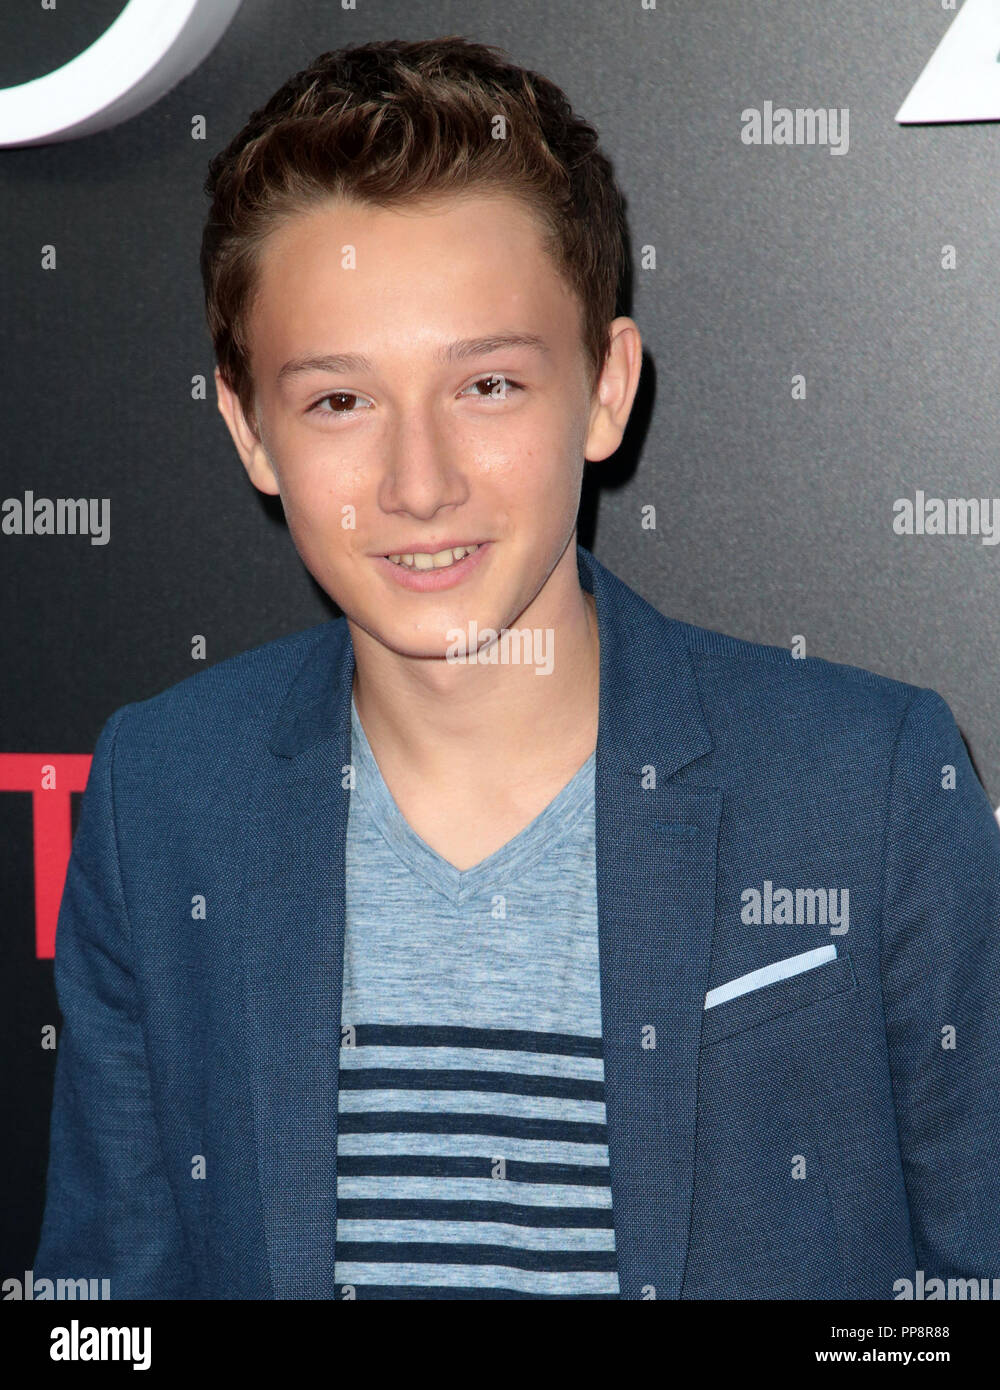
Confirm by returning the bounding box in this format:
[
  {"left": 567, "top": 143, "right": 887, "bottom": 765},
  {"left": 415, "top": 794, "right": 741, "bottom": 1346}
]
[{"left": 216, "top": 195, "right": 640, "bottom": 657}]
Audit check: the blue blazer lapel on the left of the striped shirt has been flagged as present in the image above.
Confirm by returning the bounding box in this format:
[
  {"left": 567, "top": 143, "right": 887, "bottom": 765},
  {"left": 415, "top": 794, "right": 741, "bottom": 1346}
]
[{"left": 243, "top": 621, "right": 353, "bottom": 1298}]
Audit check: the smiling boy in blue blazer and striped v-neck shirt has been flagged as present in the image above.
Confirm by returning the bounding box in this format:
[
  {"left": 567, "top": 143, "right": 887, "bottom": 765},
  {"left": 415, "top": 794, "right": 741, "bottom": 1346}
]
[{"left": 35, "top": 38, "right": 1000, "bottom": 1298}]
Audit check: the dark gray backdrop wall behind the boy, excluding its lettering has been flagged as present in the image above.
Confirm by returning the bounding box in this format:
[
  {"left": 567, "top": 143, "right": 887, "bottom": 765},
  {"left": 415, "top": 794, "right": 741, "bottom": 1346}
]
[{"left": 0, "top": 0, "right": 1000, "bottom": 1275}]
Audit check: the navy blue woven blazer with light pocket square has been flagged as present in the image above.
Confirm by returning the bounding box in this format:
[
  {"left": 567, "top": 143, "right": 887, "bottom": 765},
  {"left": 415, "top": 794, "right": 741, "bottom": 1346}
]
[{"left": 35, "top": 546, "right": 1000, "bottom": 1298}]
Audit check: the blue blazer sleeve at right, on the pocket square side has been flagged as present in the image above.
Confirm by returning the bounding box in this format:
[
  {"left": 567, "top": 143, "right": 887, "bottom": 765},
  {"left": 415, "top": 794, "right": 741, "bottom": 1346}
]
[{"left": 880, "top": 689, "right": 1000, "bottom": 1279}]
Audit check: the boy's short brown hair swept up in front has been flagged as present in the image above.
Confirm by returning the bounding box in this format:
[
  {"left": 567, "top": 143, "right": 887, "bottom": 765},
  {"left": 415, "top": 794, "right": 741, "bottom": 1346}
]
[{"left": 200, "top": 35, "right": 629, "bottom": 428}]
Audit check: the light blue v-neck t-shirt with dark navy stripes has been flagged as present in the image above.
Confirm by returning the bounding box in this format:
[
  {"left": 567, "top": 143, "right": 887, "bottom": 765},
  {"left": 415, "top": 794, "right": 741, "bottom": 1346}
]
[{"left": 334, "top": 701, "right": 619, "bottom": 1298}]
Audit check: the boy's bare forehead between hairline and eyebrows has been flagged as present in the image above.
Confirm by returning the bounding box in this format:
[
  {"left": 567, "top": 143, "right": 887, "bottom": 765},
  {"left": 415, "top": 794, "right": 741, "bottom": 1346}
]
[{"left": 244, "top": 193, "right": 580, "bottom": 379}]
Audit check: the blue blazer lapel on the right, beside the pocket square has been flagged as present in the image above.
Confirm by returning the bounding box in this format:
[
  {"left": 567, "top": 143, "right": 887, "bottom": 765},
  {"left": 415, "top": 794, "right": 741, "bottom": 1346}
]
[{"left": 577, "top": 548, "right": 722, "bottom": 1298}]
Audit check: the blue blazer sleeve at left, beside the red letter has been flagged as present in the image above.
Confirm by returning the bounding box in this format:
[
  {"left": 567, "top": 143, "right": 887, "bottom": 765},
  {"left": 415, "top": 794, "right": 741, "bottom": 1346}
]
[{"left": 33, "top": 705, "right": 197, "bottom": 1298}]
